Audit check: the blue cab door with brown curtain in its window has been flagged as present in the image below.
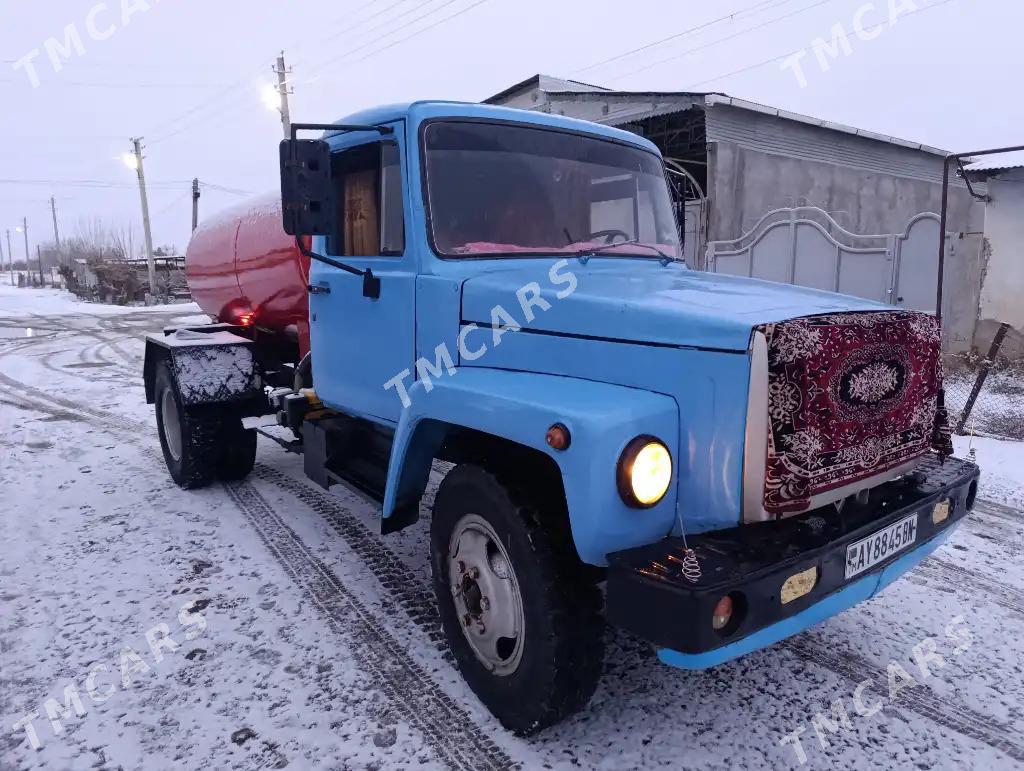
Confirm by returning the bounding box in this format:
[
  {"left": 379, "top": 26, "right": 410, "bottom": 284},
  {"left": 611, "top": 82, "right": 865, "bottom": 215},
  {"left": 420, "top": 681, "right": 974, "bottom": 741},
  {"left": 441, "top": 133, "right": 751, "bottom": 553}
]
[{"left": 309, "top": 123, "right": 416, "bottom": 423}]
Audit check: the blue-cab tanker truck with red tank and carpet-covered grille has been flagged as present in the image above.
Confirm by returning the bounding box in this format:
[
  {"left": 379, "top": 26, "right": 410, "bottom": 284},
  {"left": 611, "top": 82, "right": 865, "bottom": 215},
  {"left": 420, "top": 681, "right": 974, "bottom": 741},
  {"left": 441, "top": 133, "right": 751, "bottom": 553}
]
[{"left": 144, "top": 101, "right": 979, "bottom": 735}]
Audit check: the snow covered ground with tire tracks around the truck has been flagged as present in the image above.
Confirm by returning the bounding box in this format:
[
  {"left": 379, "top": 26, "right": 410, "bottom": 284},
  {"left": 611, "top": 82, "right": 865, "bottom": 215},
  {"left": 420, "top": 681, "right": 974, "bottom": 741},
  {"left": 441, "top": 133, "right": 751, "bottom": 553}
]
[{"left": 0, "top": 286, "right": 1024, "bottom": 771}]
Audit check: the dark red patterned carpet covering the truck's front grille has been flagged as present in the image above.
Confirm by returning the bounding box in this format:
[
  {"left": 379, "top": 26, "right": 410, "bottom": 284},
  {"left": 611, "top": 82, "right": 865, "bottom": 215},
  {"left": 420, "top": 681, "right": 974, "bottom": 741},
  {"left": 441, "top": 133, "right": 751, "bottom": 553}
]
[{"left": 744, "top": 311, "right": 942, "bottom": 521}]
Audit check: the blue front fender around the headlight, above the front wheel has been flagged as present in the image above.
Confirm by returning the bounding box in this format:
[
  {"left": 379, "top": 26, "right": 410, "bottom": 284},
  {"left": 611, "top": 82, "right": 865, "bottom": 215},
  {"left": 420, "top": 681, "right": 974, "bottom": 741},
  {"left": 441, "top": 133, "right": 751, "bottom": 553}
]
[{"left": 384, "top": 368, "right": 679, "bottom": 565}]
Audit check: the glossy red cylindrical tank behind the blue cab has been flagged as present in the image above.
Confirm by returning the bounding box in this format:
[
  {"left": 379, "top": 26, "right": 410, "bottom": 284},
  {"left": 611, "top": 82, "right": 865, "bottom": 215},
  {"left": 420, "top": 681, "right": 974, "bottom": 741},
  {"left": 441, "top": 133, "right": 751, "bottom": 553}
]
[{"left": 185, "top": 194, "right": 309, "bottom": 355}]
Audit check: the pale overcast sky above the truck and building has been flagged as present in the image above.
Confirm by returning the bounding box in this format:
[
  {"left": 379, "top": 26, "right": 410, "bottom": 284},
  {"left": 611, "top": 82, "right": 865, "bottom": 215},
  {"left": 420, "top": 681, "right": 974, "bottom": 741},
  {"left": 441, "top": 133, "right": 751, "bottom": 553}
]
[{"left": 0, "top": 0, "right": 1024, "bottom": 257}]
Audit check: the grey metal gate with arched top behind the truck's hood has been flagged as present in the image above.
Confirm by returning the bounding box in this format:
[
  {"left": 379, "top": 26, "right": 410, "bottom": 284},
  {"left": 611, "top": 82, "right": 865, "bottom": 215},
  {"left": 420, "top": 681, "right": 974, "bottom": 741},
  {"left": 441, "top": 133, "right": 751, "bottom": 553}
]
[{"left": 708, "top": 207, "right": 939, "bottom": 313}]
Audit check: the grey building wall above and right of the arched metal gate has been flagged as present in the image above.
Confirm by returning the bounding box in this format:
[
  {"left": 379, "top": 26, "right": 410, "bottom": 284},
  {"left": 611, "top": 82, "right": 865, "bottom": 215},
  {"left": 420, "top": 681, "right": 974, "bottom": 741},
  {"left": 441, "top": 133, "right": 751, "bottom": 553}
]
[{"left": 708, "top": 105, "right": 983, "bottom": 352}]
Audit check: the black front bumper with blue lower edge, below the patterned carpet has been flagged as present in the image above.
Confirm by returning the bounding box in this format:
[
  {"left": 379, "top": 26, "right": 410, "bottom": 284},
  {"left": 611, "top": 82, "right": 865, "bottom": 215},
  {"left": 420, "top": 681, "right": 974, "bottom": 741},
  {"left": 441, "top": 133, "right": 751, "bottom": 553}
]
[{"left": 607, "top": 457, "right": 979, "bottom": 669}]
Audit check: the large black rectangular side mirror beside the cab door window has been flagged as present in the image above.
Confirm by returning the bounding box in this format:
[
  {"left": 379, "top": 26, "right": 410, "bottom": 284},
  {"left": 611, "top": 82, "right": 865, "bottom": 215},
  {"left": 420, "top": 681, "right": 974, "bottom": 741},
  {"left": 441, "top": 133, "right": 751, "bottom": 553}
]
[{"left": 281, "top": 139, "right": 338, "bottom": 235}]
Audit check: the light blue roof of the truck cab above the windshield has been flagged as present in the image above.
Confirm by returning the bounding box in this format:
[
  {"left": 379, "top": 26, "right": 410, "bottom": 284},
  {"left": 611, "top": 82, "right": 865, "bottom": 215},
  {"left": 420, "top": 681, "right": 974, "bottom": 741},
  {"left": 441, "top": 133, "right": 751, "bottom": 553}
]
[{"left": 325, "top": 99, "right": 660, "bottom": 155}]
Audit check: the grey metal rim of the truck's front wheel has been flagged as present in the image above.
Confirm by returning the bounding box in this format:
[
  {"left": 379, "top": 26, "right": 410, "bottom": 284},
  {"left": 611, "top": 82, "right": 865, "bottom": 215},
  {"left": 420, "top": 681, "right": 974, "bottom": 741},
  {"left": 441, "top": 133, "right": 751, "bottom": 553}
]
[{"left": 449, "top": 514, "right": 526, "bottom": 676}]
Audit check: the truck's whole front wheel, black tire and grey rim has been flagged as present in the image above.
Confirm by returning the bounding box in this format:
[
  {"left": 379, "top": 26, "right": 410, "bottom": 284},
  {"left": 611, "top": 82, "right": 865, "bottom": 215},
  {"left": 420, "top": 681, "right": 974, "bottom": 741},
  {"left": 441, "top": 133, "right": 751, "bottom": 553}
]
[{"left": 430, "top": 464, "right": 604, "bottom": 736}]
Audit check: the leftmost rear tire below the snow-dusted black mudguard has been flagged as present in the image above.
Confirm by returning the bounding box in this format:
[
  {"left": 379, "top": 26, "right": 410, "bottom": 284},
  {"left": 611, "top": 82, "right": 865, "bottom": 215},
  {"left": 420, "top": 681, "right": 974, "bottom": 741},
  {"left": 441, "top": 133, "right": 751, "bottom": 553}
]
[{"left": 154, "top": 361, "right": 221, "bottom": 489}]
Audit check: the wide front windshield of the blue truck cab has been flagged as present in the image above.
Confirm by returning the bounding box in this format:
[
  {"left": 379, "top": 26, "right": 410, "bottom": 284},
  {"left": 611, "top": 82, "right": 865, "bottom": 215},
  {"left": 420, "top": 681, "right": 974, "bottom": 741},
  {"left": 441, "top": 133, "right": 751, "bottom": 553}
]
[{"left": 424, "top": 121, "right": 680, "bottom": 259}]
